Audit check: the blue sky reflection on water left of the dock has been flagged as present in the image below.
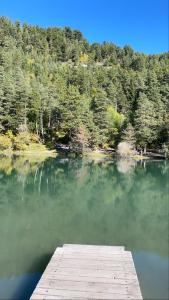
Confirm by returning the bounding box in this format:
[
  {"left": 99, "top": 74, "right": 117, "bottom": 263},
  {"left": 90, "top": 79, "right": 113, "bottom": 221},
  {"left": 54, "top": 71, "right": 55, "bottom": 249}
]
[{"left": 0, "top": 273, "right": 40, "bottom": 300}]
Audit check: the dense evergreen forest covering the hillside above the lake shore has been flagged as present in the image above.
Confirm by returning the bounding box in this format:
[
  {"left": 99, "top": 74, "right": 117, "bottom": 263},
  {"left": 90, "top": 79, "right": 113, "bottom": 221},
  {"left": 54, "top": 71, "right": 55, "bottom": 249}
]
[{"left": 0, "top": 17, "right": 169, "bottom": 155}]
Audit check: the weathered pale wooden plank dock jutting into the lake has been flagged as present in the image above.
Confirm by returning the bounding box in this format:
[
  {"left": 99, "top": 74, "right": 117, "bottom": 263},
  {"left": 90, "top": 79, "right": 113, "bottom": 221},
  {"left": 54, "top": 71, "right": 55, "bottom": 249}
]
[{"left": 30, "top": 244, "right": 143, "bottom": 300}]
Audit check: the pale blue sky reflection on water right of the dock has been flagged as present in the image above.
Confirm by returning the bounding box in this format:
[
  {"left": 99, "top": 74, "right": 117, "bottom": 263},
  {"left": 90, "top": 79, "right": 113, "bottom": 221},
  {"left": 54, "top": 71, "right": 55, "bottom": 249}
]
[{"left": 133, "top": 251, "right": 169, "bottom": 300}]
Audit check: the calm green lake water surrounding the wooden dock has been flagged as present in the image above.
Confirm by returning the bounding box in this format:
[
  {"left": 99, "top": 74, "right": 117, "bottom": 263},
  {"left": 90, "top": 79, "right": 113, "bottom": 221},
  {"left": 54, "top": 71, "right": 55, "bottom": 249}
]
[{"left": 0, "top": 157, "right": 169, "bottom": 300}]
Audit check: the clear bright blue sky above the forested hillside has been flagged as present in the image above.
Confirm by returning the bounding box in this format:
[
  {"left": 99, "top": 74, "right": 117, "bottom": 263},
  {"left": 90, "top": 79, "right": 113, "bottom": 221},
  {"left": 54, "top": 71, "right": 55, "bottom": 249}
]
[{"left": 0, "top": 0, "right": 169, "bottom": 54}]
